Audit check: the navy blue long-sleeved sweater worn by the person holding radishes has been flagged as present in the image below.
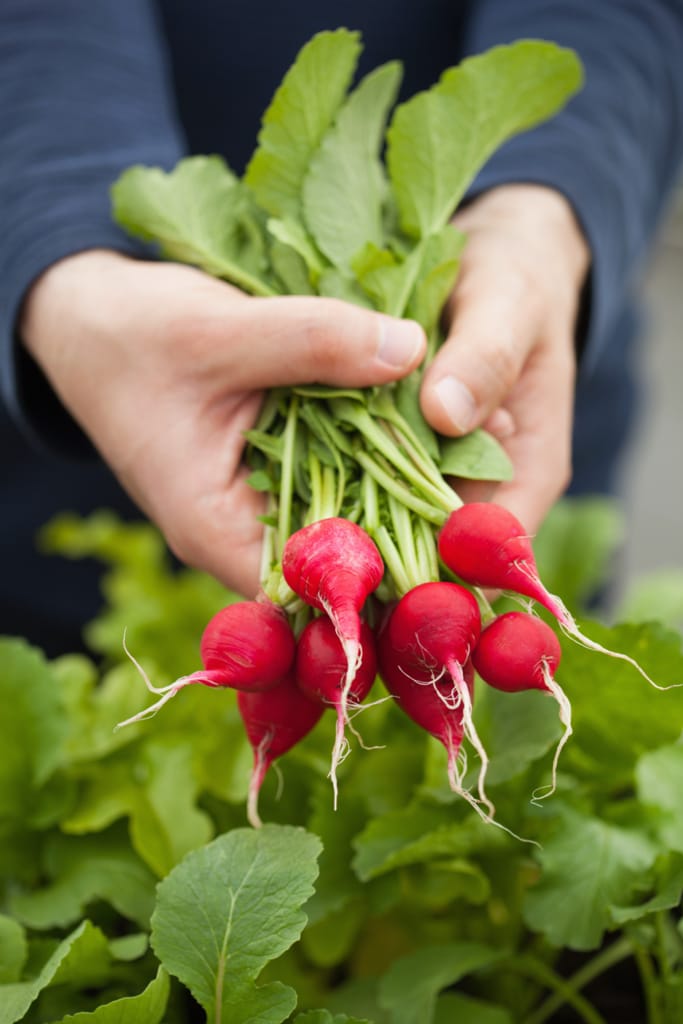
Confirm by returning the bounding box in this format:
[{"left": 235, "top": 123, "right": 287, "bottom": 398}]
[{"left": 0, "top": 0, "right": 683, "bottom": 646}]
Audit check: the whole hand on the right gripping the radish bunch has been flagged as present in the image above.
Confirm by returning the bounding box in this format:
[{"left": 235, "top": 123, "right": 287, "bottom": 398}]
[{"left": 422, "top": 184, "right": 590, "bottom": 532}]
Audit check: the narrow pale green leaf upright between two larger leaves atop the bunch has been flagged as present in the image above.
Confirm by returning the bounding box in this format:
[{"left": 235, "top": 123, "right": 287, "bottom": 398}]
[{"left": 302, "top": 61, "right": 401, "bottom": 270}]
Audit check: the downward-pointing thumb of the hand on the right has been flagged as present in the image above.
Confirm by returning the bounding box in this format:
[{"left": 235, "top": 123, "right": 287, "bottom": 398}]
[{"left": 421, "top": 259, "right": 539, "bottom": 435}]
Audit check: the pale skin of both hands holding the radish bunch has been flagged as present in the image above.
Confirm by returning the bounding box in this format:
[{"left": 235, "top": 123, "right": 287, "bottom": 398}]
[{"left": 19, "top": 185, "right": 590, "bottom": 596}]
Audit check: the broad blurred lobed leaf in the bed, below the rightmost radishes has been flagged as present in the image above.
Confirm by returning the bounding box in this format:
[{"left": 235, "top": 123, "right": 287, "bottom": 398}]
[{"left": 523, "top": 810, "right": 657, "bottom": 951}]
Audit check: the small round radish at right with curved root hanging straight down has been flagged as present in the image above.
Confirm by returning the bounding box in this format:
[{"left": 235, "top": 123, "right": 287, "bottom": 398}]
[{"left": 472, "top": 611, "right": 572, "bottom": 799}]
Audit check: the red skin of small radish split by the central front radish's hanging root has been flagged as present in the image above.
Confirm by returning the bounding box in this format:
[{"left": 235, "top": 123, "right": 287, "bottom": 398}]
[{"left": 295, "top": 615, "right": 377, "bottom": 708}]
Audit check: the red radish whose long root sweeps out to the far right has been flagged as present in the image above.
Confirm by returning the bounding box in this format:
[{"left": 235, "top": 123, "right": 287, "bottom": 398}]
[{"left": 438, "top": 502, "right": 671, "bottom": 690}]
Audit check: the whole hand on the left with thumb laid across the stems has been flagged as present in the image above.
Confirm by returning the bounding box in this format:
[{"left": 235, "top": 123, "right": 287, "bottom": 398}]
[{"left": 19, "top": 250, "right": 425, "bottom": 596}]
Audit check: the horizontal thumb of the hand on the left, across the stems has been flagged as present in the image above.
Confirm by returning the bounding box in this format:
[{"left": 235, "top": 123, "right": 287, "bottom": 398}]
[{"left": 214, "top": 296, "right": 426, "bottom": 388}]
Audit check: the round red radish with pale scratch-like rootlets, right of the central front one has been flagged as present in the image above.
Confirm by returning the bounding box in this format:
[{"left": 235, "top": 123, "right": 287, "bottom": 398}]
[{"left": 388, "top": 583, "right": 494, "bottom": 815}]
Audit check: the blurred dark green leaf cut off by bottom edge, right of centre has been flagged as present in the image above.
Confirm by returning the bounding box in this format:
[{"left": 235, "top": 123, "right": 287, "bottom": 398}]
[{"left": 379, "top": 942, "right": 504, "bottom": 1024}]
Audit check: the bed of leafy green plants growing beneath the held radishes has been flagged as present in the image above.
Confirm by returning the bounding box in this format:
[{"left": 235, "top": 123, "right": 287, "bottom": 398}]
[{"left": 0, "top": 502, "right": 683, "bottom": 1024}]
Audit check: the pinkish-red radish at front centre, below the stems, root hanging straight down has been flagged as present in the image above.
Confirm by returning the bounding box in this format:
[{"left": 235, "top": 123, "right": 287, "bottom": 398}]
[{"left": 283, "top": 516, "right": 384, "bottom": 807}]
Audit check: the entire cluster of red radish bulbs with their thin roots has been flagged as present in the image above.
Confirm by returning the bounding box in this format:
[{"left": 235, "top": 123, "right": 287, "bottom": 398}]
[{"left": 121, "top": 495, "right": 671, "bottom": 826}]
